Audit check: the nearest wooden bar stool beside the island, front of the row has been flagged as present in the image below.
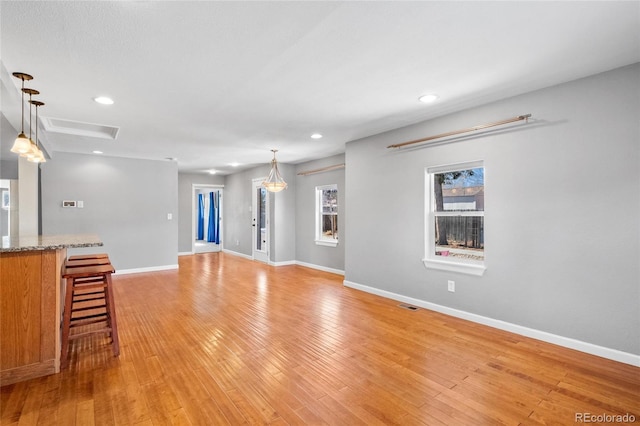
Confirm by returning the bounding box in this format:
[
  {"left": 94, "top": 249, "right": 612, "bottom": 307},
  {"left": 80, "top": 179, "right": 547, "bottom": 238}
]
[{"left": 60, "top": 258, "right": 120, "bottom": 369}]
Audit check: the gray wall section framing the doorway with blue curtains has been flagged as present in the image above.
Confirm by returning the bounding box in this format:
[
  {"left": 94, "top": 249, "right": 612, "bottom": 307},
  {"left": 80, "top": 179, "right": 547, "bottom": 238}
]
[{"left": 177, "top": 173, "right": 226, "bottom": 253}]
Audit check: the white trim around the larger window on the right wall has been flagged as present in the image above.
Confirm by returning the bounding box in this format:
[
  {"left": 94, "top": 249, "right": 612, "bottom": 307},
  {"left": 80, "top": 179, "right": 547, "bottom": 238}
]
[{"left": 422, "top": 160, "right": 487, "bottom": 276}]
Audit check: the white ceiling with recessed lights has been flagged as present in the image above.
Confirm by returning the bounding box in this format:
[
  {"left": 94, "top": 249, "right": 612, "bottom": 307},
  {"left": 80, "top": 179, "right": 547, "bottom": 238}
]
[{"left": 0, "top": 1, "right": 640, "bottom": 174}]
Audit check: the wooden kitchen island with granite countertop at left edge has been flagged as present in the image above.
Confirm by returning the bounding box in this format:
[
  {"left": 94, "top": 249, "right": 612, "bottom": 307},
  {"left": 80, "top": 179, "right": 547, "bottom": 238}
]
[{"left": 0, "top": 235, "right": 102, "bottom": 386}]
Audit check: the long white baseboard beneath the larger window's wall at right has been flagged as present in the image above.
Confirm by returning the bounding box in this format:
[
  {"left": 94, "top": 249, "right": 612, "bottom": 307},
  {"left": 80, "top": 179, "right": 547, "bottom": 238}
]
[{"left": 343, "top": 280, "right": 640, "bottom": 367}]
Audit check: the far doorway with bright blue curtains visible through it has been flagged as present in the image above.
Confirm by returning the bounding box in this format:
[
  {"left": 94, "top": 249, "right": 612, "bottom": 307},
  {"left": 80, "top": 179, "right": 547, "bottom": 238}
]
[{"left": 191, "top": 184, "right": 224, "bottom": 253}]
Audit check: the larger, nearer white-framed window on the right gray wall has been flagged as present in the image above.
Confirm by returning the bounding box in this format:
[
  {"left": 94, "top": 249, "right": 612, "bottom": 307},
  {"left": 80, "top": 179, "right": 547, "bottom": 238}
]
[{"left": 424, "top": 161, "right": 485, "bottom": 275}]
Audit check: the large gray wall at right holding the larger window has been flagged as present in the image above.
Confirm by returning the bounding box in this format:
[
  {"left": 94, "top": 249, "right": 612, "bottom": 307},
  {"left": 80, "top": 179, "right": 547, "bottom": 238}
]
[{"left": 345, "top": 64, "right": 640, "bottom": 354}]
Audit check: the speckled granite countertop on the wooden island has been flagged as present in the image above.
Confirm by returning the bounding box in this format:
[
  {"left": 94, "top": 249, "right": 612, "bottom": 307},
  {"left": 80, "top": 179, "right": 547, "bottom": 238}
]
[{"left": 0, "top": 234, "right": 102, "bottom": 253}]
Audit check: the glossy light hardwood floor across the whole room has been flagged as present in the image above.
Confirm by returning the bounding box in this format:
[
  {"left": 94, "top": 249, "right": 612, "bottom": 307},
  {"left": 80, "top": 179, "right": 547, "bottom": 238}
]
[{"left": 0, "top": 253, "right": 640, "bottom": 426}]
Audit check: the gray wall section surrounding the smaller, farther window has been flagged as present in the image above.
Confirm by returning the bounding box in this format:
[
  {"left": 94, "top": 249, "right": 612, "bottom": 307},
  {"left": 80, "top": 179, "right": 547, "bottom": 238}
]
[{"left": 295, "top": 154, "right": 346, "bottom": 271}]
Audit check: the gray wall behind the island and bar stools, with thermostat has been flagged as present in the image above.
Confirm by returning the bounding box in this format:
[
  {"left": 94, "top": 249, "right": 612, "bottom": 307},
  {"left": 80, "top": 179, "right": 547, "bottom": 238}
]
[{"left": 41, "top": 153, "right": 178, "bottom": 270}]
